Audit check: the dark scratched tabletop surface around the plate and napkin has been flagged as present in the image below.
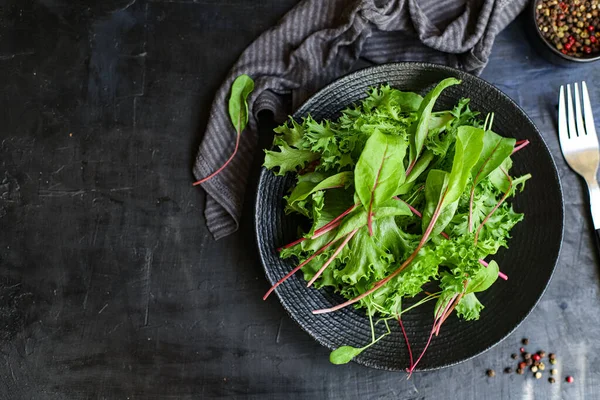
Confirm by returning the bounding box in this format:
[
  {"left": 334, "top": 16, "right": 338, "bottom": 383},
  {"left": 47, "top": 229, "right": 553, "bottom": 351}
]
[{"left": 0, "top": 0, "right": 600, "bottom": 400}]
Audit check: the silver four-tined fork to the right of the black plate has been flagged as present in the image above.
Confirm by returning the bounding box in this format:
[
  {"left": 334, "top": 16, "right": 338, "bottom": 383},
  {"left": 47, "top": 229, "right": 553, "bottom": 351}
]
[{"left": 558, "top": 82, "right": 600, "bottom": 238}]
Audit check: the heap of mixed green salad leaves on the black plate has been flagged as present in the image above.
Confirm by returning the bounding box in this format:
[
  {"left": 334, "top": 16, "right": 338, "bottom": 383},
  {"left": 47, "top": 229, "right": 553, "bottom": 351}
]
[{"left": 264, "top": 78, "right": 530, "bottom": 372}]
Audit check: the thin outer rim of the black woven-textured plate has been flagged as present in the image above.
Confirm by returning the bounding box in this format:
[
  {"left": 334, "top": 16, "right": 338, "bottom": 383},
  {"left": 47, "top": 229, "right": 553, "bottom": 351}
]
[{"left": 254, "top": 62, "right": 565, "bottom": 372}]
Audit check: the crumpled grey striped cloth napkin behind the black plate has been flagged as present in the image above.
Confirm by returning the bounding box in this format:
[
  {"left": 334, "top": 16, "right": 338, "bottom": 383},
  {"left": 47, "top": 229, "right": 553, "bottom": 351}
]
[{"left": 193, "top": 0, "right": 527, "bottom": 239}]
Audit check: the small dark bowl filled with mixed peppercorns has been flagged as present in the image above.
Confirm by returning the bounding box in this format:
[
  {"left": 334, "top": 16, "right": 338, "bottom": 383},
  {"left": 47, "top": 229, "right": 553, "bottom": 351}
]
[{"left": 530, "top": 0, "right": 600, "bottom": 66}]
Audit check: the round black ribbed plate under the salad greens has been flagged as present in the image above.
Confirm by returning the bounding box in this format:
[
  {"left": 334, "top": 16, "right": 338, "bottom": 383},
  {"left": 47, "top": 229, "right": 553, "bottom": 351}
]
[{"left": 256, "top": 63, "right": 564, "bottom": 370}]
